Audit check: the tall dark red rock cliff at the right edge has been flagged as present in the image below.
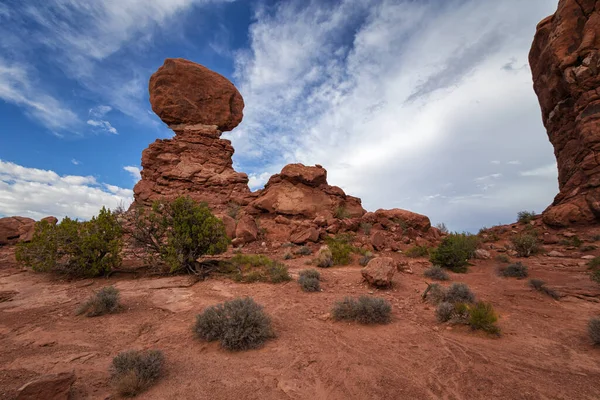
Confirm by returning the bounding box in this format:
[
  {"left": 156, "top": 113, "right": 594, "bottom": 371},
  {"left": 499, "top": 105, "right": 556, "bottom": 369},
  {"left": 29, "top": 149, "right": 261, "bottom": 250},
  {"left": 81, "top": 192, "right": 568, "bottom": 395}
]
[{"left": 529, "top": 0, "right": 600, "bottom": 227}]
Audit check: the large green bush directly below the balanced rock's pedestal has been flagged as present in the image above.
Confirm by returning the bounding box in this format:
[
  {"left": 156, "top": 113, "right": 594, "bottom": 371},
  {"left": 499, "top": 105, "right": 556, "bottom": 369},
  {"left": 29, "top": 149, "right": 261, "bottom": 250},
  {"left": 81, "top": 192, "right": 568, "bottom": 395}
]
[{"left": 130, "top": 197, "right": 229, "bottom": 274}]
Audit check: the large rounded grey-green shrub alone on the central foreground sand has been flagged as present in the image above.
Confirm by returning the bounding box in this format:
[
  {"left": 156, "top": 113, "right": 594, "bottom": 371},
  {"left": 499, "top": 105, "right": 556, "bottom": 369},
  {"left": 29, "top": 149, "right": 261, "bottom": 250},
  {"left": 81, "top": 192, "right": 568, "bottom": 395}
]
[{"left": 194, "top": 297, "right": 274, "bottom": 351}]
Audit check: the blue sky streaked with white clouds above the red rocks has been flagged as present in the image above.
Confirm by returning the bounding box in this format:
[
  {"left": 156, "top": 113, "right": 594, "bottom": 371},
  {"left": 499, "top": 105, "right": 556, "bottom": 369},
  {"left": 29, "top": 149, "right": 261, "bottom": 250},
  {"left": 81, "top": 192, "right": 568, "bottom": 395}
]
[{"left": 0, "top": 0, "right": 557, "bottom": 231}]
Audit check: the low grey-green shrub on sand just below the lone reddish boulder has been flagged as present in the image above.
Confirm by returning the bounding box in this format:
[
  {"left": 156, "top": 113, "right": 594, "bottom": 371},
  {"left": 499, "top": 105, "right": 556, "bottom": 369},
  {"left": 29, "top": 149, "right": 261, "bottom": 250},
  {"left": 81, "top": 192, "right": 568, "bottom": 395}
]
[{"left": 331, "top": 296, "right": 392, "bottom": 325}]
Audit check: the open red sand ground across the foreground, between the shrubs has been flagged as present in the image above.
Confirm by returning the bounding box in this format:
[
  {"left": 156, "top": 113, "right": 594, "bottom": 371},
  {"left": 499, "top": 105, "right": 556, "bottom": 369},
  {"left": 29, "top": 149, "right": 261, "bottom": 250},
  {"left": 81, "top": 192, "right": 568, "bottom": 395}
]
[{"left": 0, "top": 239, "right": 600, "bottom": 399}]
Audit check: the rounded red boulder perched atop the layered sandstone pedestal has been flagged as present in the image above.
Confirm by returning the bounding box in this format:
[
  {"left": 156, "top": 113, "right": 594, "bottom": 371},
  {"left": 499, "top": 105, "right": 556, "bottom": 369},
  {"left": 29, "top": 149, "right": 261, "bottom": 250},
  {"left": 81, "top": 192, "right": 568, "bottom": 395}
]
[{"left": 149, "top": 58, "right": 244, "bottom": 131}]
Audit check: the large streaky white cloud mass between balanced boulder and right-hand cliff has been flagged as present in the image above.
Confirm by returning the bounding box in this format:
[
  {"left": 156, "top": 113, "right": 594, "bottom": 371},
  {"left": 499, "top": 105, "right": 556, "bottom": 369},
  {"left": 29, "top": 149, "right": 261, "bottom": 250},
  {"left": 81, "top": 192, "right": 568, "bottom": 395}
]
[{"left": 227, "top": 0, "right": 556, "bottom": 229}]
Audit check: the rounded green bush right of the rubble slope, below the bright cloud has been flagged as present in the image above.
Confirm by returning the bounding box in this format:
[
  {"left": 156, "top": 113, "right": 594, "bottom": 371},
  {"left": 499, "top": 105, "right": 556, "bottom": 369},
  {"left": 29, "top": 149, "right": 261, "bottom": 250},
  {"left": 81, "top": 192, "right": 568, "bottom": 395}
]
[{"left": 430, "top": 233, "right": 479, "bottom": 272}]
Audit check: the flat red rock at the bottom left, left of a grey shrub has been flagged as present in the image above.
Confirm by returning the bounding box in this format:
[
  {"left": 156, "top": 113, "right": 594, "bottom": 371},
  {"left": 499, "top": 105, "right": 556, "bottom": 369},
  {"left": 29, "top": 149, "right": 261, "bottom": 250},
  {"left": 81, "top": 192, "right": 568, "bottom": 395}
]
[{"left": 17, "top": 372, "right": 75, "bottom": 400}]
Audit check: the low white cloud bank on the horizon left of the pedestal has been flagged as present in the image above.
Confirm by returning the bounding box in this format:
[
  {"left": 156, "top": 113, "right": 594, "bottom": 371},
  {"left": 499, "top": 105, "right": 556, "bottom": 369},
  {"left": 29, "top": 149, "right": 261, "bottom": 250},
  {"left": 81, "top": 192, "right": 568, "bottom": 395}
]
[{"left": 0, "top": 160, "right": 133, "bottom": 219}]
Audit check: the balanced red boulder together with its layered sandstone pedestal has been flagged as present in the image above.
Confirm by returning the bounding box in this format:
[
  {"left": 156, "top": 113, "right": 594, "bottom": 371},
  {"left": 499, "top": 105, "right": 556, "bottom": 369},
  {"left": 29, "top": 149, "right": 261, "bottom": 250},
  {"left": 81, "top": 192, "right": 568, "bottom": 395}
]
[{"left": 134, "top": 59, "right": 251, "bottom": 213}]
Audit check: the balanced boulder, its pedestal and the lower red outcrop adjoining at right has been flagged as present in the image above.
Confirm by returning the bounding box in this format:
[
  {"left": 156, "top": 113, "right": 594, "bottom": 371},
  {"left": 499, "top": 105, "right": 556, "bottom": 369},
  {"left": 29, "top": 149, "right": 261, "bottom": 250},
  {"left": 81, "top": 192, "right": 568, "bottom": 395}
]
[{"left": 134, "top": 55, "right": 436, "bottom": 244}]
